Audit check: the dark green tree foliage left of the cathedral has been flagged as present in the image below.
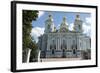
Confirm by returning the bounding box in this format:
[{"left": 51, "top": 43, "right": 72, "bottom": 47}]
[{"left": 22, "top": 10, "right": 38, "bottom": 62}]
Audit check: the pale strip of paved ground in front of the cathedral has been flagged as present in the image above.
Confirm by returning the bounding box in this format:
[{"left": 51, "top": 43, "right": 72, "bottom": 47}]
[{"left": 41, "top": 58, "right": 81, "bottom": 62}]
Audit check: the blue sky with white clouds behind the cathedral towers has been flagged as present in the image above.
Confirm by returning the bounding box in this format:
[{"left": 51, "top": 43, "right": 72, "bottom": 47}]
[{"left": 31, "top": 11, "right": 91, "bottom": 42}]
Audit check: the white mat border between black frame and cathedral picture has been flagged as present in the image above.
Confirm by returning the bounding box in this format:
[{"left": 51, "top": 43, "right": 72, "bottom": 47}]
[{"left": 16, "top": 4, "right": 96, "bottom": 70}]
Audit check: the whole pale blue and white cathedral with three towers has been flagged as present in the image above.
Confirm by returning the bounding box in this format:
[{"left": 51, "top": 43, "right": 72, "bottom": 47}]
[{"left": 38, "top": 15, "right": 91, "bottom": 58}]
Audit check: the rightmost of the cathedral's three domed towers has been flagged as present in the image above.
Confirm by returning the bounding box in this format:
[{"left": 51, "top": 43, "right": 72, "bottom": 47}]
[{"left": 74, "top": 15, "right": 83, "bottom": 33}]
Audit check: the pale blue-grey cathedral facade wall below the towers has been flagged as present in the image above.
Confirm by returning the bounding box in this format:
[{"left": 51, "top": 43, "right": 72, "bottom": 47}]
[{"left": 41, "top": 33, "right": 90, "bottom": 58}]
